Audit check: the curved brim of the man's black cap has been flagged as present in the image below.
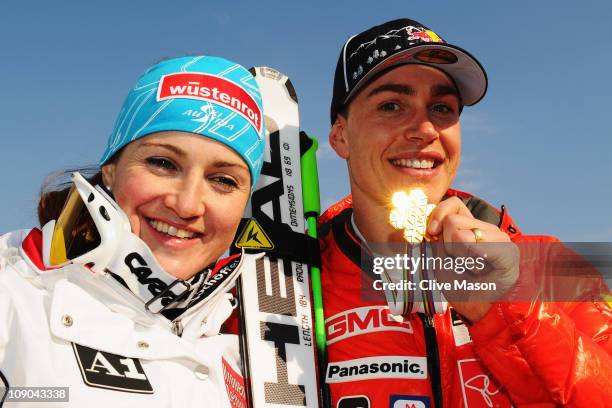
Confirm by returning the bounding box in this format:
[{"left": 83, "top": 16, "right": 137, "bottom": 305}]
[{"left": 344, "top": 43, "right": 488, "bottom": 106}]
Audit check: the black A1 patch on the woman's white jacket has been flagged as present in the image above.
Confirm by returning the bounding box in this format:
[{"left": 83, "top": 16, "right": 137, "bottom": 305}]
[{"left": 72, "top": 343, "right": 153, "bottom": 394}]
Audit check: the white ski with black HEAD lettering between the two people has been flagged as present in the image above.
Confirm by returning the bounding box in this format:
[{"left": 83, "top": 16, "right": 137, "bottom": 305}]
[{"left": 234, "top": 67, "right": 319, "bottom": 408}]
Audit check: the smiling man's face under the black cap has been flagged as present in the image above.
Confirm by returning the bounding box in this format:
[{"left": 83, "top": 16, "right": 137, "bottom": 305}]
[{"left": 330, "top": 65, "right": 461, "bottom": 206}]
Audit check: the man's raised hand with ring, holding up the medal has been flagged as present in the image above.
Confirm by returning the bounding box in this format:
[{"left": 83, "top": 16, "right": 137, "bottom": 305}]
[{"left": 427, "top": 197, "right": 519, "bottom": 323}]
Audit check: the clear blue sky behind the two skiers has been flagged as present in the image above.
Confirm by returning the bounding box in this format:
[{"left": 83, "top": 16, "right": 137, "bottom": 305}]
[{"left": 0, "top": 0, "right": 612, "bottom": 242}]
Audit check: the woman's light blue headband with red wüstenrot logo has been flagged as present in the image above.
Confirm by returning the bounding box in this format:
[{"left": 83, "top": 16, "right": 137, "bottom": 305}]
[{"left": 100, "top": 56, "right": 264, "bottom": 186}]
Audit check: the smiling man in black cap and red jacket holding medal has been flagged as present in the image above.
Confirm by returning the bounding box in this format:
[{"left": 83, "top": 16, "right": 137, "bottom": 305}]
[{"left": 320, "top": 19, "right": 612, "bottom": 408}]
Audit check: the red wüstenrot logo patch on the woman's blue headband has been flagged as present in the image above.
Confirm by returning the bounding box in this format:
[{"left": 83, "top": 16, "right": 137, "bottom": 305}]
[{"left": 157, "top": 72, "right": 262, "bottom": 133}]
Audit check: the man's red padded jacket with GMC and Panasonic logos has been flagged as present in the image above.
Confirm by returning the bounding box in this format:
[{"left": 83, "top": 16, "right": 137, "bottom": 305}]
[{"left": 319, "top": 190, "right": 612, "bottom": 408}]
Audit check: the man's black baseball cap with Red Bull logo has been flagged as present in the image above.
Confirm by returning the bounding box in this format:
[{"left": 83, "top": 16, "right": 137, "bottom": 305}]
[{"left": 331, "top": 18, "right": 487, "bottom": 124}]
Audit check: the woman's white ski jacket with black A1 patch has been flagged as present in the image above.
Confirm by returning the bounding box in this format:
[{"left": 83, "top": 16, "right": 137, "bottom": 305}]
[{"left": 0, "top": 230, "right": 253, "bottom": 408}]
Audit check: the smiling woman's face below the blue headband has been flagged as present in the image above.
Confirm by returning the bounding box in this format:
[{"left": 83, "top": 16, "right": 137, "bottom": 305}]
[{"left": 102, "top": 131, "right": 251, "bottom": 279}]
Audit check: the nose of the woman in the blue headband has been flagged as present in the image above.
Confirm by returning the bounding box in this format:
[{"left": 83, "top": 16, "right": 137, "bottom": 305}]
[{"left": 165, "top": 175, "right": 206, "bottom": 219}]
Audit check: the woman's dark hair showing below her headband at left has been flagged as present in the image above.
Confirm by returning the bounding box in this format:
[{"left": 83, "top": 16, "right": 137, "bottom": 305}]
[{"left": 37, "top": 166, "right": 103, "bottom": 227}]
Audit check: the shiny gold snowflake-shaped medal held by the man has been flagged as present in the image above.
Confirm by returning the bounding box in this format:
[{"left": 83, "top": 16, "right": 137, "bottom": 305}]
[{"left": 389, "top": 188, "right": 436, "bottom": 244}]
